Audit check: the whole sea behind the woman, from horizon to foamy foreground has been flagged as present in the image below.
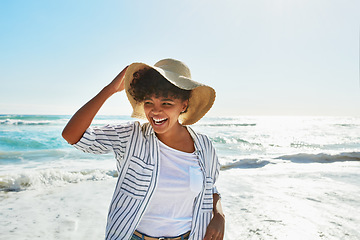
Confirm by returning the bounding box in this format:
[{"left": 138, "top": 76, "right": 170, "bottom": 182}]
[{"left": 0, "top": 115, "right": 360, "bottom": 240}]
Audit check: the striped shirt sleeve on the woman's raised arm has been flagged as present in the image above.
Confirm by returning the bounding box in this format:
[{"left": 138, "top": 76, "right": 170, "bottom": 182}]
[{"left": 73, "top": 123, "right": 134, "bottom": 157}]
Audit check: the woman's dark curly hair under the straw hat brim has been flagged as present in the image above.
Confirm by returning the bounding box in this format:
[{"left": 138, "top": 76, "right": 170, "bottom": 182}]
[{"left": 129, "top": 68, "right": 191, "bottom": 102}]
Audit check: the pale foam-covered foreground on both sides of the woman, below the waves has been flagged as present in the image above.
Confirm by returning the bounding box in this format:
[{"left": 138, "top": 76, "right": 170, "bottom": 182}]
[{"left": 0, "top": 162, "right": 360, "bottom": 240}]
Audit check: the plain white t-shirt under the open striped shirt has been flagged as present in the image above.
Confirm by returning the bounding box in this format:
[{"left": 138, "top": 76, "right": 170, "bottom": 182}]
[{"left": 137, "top": 141, "right": 203, "bottom": 237}]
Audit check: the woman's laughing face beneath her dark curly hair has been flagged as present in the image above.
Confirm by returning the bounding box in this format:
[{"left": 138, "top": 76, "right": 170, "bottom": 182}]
[{"left": 144, "top": 97, "right": 188, "bottom": 135}]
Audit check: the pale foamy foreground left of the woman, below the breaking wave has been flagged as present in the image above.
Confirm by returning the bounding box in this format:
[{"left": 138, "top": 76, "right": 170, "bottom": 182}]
[{"left": 0, "top": 178, "right": 116, "bottom": 240}]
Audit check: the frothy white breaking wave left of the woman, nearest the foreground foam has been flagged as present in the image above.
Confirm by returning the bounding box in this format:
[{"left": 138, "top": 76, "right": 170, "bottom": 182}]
[{"left": 0, "top": 169, "right": 118, "bottom": 192}]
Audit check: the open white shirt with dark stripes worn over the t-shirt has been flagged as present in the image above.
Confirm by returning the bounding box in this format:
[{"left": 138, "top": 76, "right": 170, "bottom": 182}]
[{"left": 74, "top": 122, "right": 220, "bottom": 240}]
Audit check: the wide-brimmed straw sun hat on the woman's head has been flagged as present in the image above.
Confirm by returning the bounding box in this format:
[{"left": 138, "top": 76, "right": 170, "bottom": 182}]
[{"left": 124, "top": 59, "right": 215, "bottom": 125}]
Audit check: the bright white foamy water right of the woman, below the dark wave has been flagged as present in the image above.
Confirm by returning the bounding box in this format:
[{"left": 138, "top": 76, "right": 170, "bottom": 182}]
[{"left": 218, "top": 162, "right": 360, "bottom": 240}]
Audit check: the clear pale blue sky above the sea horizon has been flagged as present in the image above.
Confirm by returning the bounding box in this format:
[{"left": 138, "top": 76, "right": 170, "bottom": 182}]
[{"left": 0, "top": 0, "right": 360, "bottom": 116}]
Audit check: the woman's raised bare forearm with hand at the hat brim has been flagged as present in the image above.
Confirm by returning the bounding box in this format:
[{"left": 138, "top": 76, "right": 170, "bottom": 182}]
[{"left": 62, "top": 67, "right": 127, "bottom": 144}]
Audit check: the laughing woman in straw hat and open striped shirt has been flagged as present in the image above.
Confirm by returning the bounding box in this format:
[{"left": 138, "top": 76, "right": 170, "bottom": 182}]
[{"left": 63, "top": 59, "right": 225, "bottom": 240}]
